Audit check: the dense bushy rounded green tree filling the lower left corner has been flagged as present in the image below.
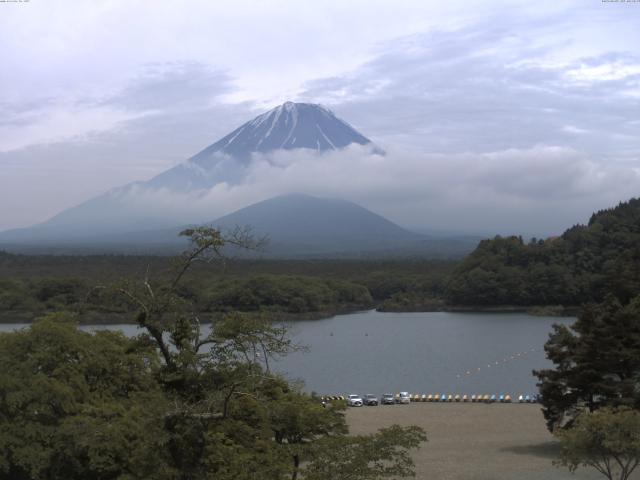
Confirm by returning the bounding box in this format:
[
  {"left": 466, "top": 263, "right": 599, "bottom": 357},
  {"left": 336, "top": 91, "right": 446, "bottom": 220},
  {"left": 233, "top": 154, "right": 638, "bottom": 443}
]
[{"left": 0, "top": 315, "right": 175, "bottom": 480}]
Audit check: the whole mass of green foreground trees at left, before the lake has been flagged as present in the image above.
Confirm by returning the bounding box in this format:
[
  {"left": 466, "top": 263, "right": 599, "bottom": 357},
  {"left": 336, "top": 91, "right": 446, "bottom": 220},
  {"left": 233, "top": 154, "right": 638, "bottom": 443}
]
[{"left": 0, "top": 228, "right": 424, "bottom": 480}]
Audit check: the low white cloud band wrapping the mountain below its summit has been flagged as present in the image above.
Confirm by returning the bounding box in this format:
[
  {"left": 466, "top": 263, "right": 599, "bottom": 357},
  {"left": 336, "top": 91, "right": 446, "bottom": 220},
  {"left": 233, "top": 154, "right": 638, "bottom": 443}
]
[{"left": 111, "top": 146, "right": 640, "bottom": 235}]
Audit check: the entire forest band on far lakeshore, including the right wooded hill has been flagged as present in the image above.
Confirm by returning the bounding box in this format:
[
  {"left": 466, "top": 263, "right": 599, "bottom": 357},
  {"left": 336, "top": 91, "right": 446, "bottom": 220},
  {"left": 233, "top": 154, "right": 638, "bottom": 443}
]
[{"left": 0, "top": 199, "right": 640, "bottom": 323}]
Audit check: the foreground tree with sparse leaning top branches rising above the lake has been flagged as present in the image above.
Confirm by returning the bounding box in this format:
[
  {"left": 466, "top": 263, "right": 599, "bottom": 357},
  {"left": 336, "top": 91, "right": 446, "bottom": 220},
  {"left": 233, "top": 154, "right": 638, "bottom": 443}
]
[{"left": 85, "top": 227, "right": 422, "bottom": 480}]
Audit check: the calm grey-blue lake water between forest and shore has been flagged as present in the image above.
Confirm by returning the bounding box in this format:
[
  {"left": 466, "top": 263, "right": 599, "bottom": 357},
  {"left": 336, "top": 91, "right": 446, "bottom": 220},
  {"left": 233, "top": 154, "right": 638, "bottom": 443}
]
[{"left": 0, "top": 311, "right": 574, "bottom": 396}]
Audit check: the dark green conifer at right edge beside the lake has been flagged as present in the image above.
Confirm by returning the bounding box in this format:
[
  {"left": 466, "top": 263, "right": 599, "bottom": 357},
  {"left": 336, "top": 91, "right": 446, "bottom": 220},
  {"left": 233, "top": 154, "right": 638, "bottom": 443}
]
[{"left": 534, "top": 296, "right": 640, "bottom": 430}]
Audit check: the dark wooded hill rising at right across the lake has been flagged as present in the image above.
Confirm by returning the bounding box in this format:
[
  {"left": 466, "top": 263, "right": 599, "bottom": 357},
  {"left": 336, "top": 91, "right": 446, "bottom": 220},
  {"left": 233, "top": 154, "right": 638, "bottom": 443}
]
[{"left": 445, "top": 199, "right": 640, "bottom": 306}]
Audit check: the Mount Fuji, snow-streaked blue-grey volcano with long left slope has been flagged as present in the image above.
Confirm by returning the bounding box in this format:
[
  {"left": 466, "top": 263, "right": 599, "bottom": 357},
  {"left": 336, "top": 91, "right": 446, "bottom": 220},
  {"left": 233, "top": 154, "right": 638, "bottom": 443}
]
[{"left": 0, "top": 102, "right": 384, "bottom": 245}]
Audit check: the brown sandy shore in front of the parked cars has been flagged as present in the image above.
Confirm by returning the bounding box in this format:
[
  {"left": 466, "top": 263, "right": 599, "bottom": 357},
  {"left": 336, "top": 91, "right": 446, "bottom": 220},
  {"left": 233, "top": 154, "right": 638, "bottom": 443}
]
[{"left": 347, "top": 403, "right": 640, "bottom": 480}]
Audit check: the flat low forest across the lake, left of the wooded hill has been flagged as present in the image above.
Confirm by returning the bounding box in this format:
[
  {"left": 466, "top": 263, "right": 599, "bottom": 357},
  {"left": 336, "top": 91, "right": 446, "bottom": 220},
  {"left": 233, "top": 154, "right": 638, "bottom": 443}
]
[{"left": 0, "top": 252, "right": 455, "bottom": 322}]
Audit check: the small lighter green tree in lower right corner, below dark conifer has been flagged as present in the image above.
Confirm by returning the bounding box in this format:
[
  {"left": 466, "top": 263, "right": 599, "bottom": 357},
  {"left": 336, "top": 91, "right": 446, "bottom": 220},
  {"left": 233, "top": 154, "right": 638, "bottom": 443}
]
[{"left": 555, "top": 407, "right": 640, "bottom": 480}]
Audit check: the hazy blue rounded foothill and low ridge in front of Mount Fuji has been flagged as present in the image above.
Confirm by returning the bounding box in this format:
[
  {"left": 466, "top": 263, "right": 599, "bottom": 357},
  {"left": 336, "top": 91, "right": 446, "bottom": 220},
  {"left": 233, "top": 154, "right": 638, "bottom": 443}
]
[{"left": 0, "top": 194, "right": 480, "bottom": 258}]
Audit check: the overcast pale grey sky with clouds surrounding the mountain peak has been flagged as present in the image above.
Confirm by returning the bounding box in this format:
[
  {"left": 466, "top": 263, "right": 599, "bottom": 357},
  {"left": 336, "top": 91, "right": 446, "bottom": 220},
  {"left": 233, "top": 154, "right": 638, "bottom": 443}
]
[{"left": 0, "top": 0, "right": 640, "bottom": 234}]
